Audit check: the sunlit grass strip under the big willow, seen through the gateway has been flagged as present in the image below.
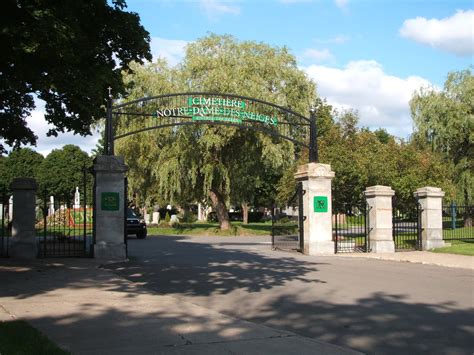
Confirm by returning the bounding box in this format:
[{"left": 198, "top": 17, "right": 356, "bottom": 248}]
[{"left": 148, "top": 221, "right": 272, "bottom": 236}]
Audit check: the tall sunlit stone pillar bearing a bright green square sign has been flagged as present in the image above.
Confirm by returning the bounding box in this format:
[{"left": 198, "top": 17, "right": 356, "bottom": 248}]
[{"left": 295, "top": 163, "right": 334, "bottom": 255}]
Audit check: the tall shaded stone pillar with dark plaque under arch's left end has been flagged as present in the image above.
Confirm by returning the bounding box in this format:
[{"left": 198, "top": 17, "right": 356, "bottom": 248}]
[{"left": 94, "top": 155, "right": 128, "bottom": 260}]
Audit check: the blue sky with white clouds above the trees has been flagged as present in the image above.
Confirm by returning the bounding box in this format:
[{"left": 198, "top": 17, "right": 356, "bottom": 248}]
[{"left": 20, "top": 0, "right": 474, "bottom": 155}]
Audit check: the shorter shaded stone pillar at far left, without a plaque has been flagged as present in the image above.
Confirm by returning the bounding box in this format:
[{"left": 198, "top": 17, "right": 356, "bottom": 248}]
[{"left": 9, "top": 178, "right": 38, "bottom": 259}]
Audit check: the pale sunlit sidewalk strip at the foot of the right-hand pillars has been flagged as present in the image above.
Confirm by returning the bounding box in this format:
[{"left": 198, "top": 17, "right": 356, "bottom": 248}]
[{"left": 336, "top": 251, "right": 474, "bottom": 270}]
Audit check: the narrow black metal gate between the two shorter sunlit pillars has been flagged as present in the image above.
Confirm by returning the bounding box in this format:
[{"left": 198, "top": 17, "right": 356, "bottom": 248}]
[{"left": 392, "top": 196, "right": 422, "bottom": 251}]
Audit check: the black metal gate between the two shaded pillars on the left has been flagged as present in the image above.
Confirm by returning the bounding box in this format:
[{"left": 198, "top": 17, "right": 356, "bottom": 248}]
[{"left": 36, "top": 169, "right": 95, "bottom": 258}]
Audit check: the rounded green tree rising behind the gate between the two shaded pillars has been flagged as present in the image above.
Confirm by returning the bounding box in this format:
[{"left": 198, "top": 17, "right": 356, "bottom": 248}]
[{"left": 38, "top": 144, "right": 92, "bottom": 199}]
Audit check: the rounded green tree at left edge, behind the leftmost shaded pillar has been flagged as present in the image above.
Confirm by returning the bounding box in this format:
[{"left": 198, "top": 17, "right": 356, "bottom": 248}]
[{"left": 0, "top": 148, "right": 44, "bottom": 190}]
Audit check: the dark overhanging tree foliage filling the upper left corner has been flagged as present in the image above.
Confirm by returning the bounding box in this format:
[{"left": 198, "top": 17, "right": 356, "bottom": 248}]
[{"left": 0, "top": 0, "right": 151, "bottom": 153}]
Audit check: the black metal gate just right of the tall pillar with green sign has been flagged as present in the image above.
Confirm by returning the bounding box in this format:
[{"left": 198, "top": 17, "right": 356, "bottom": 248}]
[{"left": 332, "top": 201, "right": 370, "bottom": 253}]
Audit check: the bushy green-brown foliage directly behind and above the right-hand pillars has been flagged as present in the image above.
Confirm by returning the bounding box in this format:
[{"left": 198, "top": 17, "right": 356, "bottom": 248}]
[{"left": 320, "top": 112, "right": 454, "bottom": 211}]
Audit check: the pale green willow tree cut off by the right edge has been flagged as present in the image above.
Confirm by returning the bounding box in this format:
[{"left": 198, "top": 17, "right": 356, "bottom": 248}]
[{"left": 410, "top": 69, "right": 474, "bottom": 211}]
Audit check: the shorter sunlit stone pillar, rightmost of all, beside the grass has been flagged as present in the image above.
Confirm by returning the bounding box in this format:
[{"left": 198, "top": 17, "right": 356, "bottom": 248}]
[{"left": 414, "top": 186, "right": 444, "bottom": 250}]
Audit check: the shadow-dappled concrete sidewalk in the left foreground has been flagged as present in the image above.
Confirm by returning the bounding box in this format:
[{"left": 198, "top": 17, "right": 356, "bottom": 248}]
[{"left": 0, "top": 259, "right": 357, "bottom": 354}]
